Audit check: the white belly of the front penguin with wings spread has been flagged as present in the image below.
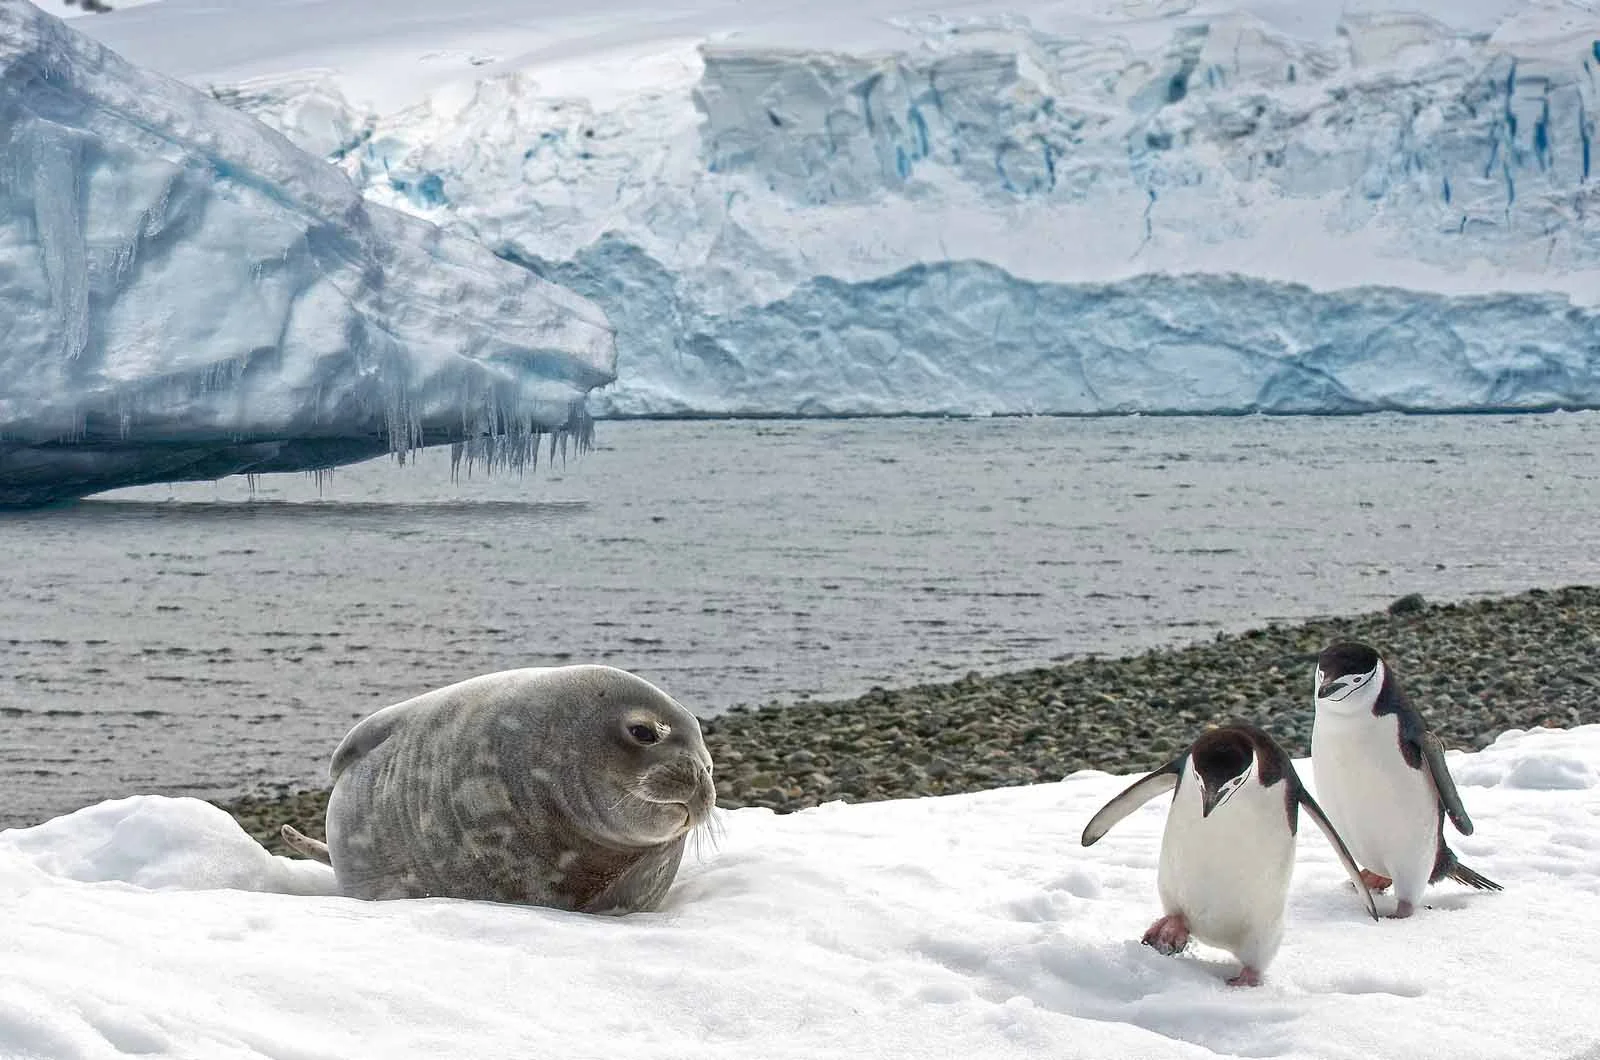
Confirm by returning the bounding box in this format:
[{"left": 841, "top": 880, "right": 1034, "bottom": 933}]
[{"left": 1157, "top": 775, "right": 1294, "bottom": 969}]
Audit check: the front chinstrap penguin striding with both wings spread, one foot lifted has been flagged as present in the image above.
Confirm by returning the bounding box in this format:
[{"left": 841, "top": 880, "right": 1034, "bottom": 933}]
[{"left": 1083, "top": 724, "right": 1378, "bottom": 986}]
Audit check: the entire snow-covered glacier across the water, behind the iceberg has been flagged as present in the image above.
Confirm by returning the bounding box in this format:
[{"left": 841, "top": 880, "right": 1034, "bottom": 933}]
[{"left": 78, "top": 0, "right": 1600, "bottom": 415}]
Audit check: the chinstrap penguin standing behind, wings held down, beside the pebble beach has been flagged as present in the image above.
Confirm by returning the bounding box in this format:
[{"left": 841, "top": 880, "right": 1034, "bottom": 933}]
[{"left": 1310, "top": 640, "right": 1501, "bottom": 917}]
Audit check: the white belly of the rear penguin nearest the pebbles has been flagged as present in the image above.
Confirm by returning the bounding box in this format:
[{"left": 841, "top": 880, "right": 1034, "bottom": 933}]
[{"left": 1310, "top": 706, "right": 1438, "bottom": 877}]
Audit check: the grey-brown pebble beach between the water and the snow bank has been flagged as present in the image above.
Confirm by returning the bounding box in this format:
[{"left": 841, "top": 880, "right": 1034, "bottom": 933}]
[{"left": 222, "top": 586, "right": 1600, "bottom": 853}]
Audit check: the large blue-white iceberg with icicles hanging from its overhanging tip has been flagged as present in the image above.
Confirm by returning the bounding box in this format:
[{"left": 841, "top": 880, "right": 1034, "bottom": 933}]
[{"left": 0, "top": 0, "right": 616, "bottom": 506}]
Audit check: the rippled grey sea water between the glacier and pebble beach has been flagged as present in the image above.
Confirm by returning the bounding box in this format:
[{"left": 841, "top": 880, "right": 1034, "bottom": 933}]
[{"left": 0, "top": 413, "right": 1600, "bottom": 826}]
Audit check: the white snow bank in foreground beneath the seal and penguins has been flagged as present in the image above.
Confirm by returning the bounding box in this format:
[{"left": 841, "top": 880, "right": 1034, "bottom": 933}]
[{"left": 0, "top": 725, "right": 1600, "bottom": 1060}]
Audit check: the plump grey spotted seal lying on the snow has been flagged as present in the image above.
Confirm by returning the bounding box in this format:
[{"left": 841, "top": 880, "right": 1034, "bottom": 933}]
[{"left": 283, "top": 666, "right": 715, "bottom": 913}]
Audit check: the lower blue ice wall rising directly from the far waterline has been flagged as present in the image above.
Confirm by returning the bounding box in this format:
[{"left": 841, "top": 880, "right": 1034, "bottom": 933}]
[{"left": 528, "top": 239, "right": 1600, "bottom": 416}]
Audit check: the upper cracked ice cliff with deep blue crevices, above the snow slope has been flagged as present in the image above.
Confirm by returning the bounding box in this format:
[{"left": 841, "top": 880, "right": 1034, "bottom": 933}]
[{"left": 694, "top": 14, "right": 1600, "bottom": 271}]
